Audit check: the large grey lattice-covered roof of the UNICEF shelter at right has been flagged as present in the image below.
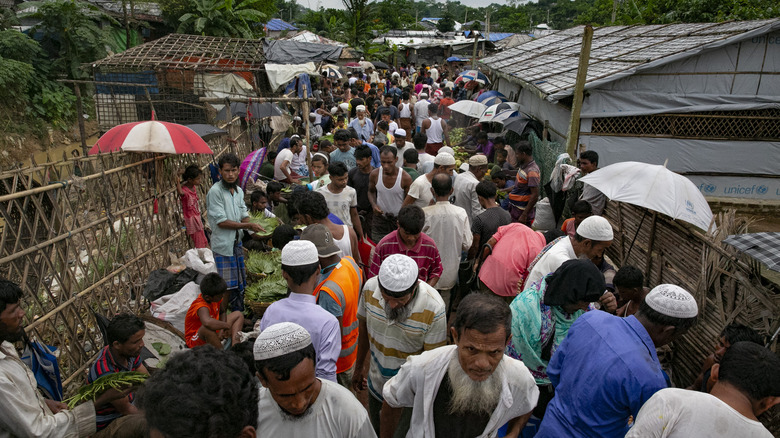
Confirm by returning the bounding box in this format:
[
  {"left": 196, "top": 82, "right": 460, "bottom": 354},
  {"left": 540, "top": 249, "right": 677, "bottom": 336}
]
[{"left": 480, "top": 19, "right": 780, "bottom": 101}]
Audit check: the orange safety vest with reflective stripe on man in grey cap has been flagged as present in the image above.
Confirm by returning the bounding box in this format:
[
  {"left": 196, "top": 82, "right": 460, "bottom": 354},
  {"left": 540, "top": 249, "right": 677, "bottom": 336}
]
[{"left": 314, "top": 257, "right": 363, "bottom": 373}]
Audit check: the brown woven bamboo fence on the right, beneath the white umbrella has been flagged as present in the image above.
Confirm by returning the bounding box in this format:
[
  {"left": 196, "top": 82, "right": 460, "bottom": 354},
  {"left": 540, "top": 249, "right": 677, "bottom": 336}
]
[{"left": 605, "top": 202, "right": 780, "bottom": 436}]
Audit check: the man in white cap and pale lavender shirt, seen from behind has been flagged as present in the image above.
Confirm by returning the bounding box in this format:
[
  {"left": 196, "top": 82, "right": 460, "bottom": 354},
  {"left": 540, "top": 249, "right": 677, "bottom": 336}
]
[{"left": 260, "top": 240, "right": 341, "bottom": 382}]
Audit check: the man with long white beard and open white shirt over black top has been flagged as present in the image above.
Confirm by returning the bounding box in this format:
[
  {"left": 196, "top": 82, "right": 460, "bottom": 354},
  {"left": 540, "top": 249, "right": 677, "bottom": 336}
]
[{"left": 383, "top": 293, "right": 539, "bottom": 438}]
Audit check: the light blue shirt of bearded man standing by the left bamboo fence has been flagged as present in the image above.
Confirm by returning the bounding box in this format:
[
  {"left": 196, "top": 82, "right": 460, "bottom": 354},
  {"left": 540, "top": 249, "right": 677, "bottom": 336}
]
[{"left": 206, "top": 182, "right": 249, "bottom": 257}]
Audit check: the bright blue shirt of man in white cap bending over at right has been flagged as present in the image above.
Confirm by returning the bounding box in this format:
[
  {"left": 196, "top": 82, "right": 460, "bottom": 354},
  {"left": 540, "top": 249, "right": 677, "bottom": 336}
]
[{"left": 536, "top": 311, "right": 667, "bottom": 438}]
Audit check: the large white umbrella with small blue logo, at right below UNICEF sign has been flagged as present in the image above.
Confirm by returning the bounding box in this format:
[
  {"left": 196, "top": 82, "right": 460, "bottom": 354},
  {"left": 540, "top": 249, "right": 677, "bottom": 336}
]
[{"left": 580, "top": 161, "right": 712, "bottom": 231}]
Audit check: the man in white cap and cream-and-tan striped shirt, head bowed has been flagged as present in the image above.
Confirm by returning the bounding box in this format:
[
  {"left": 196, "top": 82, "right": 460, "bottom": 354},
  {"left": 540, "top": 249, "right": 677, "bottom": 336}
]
[{"left": 352, "top": 254, "right": 447, "bottom": 436}]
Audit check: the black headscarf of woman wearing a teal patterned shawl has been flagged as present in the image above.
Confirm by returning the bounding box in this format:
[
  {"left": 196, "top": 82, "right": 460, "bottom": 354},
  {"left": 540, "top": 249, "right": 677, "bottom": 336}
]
[{"left": 544, "top": 259, "right": 607, "bottom": 306}]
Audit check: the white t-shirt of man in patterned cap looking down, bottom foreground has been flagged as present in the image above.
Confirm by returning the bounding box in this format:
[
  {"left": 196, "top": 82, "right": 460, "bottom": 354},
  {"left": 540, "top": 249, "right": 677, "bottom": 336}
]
[{"left": 257, "top": 379, "right": 376, "bottom": 438}]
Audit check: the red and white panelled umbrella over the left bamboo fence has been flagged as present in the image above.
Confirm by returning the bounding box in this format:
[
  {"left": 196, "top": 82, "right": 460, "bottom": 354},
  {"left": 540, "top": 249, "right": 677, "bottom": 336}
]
[{"left": 89, "top": 120, "right": 214, "bottom": 155}]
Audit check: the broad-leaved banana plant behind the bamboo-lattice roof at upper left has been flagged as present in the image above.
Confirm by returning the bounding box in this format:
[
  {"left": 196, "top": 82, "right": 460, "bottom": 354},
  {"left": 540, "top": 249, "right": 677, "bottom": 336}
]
[{"left": 177, "top": 0, "right": 268, "bottom": 38}]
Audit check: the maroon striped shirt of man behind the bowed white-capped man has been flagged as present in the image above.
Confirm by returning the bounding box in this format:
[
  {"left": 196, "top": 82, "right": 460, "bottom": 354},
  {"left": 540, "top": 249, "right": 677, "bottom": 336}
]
[{"left": 368, "top": 230, "right": 442, "bottom": 282}]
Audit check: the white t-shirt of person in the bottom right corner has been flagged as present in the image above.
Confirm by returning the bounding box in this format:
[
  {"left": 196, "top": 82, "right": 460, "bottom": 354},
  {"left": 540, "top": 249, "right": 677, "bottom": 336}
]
[{"left": 626, "top": 388, "right": 772, "bottom": 438}]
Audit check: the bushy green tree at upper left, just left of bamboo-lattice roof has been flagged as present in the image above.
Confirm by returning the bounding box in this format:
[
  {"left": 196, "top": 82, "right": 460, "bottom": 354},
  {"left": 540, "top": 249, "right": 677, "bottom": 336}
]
[{"left": 20, "top": 0, "right": 119, "bottom": 78}]
